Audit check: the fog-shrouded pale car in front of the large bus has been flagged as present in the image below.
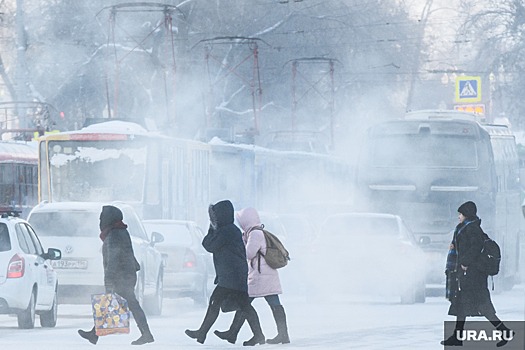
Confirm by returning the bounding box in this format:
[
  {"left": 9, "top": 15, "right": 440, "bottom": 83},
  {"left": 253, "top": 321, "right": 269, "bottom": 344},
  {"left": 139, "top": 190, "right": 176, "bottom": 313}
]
[{"left": 308, "top": 213, "right": 426, "bottom": 304}]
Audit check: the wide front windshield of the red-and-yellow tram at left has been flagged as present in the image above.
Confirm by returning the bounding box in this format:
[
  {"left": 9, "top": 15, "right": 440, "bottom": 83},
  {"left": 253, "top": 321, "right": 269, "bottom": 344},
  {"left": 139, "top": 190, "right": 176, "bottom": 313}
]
[{"left": 48, "top": 140, "right": 147, "bottom": 201}]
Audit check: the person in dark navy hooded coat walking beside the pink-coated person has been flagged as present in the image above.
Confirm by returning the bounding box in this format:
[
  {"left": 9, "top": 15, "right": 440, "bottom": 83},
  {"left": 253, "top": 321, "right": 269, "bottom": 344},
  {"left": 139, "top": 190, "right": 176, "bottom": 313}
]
[{"left": 185, "top": 200, "right": 265, "bottom": 346}]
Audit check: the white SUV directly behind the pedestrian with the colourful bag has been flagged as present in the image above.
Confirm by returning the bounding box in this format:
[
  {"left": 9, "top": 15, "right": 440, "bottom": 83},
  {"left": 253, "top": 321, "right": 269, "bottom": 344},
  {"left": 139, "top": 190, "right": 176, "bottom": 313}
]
[{"left": 28, "top": 202, "right": 164, "bottom": 315}]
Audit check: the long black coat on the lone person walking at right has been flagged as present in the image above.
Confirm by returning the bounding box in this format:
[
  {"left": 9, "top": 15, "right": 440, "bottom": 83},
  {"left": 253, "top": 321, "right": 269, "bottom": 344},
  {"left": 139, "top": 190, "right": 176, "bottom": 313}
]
[{"left": 448, "top": 217, "right": 496, "bottom": 316}]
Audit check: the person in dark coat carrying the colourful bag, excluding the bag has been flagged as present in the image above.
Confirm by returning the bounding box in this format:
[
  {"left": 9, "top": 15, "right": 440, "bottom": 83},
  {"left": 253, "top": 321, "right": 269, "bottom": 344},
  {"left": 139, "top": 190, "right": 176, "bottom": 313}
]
[{"left": 78, "top": 205, "right": 154, "bottom": 345}]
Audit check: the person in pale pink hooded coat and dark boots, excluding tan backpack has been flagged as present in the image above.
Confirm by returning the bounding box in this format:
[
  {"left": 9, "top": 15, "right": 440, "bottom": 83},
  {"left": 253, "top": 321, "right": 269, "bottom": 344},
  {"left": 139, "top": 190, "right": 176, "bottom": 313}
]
[{"left": 214, "top": 207, "right": 290, "bottom": 344}]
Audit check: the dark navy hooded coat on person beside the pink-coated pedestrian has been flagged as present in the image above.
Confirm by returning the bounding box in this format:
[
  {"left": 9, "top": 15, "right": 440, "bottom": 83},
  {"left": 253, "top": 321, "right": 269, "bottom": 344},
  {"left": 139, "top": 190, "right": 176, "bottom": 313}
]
[{"left": 202, "top": 201, "right": 248, "bottom": 292}]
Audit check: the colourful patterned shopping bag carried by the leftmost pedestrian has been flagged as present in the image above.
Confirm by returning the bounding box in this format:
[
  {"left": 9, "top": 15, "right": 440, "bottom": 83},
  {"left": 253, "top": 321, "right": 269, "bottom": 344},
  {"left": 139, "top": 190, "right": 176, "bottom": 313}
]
[{"left": 91, "top": 293, "right": 130, "bottom": 336}]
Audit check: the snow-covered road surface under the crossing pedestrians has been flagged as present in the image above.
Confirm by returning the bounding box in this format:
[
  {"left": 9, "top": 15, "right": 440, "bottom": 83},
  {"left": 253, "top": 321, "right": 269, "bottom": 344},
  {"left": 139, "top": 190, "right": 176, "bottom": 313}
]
[{"left": 0, "top": 285, "right": 525, "bottom": 350}]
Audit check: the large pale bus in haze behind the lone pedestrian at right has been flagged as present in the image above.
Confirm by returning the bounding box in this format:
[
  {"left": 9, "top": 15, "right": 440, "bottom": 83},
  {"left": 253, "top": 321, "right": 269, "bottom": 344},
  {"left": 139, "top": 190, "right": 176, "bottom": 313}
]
[{"left": 357, "top": 110, "right": 521, "bottom": 289}]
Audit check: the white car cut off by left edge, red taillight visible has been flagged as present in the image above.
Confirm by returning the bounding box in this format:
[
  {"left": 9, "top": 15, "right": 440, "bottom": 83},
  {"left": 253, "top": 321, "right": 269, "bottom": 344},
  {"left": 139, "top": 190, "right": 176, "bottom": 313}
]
[{"left": 0, "top": 213, "right": 61, "bottom": 329}]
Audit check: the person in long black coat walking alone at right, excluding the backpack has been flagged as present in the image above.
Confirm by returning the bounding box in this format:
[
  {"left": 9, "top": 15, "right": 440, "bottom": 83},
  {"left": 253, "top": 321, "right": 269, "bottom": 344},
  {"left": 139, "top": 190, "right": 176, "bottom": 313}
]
[{"left": 441, "top": 201, "right": 511, "bottom": 347}]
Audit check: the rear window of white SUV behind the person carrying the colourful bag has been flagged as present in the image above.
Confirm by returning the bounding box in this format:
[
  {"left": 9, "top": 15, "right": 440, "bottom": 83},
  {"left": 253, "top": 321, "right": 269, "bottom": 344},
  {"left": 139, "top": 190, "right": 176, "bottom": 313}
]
[{"left": 29, "top": 211, "right": 100, "bottom": 237}]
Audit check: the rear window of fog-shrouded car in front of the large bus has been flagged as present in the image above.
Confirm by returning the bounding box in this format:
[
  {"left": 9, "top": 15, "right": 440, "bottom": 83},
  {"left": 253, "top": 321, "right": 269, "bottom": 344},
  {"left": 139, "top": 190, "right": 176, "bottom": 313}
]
[{"left": 323, "top": 216, "right": 401, "bottom": 237}]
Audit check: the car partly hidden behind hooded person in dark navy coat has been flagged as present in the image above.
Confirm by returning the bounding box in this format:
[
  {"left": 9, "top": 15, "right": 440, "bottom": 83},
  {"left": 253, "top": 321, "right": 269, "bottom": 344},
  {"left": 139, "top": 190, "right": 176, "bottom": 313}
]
[{"left": 142, "top": 220, "right": 215, "bottom": 305}]
